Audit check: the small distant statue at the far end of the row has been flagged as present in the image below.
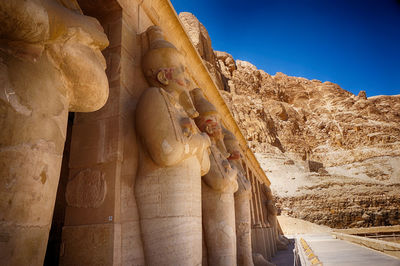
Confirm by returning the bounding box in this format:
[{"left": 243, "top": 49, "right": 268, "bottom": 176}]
[{"left": 261, "top": 185, "right": 289, "bottom": 250}]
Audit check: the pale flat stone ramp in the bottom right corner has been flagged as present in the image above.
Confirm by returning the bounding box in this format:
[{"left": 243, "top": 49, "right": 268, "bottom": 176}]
[{"left": 300, "top": 234, "right": 400, "bottom": 266}]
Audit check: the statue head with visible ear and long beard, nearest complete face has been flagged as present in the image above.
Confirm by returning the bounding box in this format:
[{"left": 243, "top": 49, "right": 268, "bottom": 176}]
[{"left": 142, "top": 26, "right": 199, "bottom": 118}]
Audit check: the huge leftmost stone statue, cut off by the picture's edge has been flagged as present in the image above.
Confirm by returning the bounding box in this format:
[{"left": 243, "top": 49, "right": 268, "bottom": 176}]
[{"left": 0, "top": 0, "right": 108, "bottom": 265}]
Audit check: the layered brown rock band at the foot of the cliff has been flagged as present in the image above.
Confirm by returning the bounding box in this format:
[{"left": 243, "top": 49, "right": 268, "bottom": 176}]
[{"left": 279, "top": 182, "right": 400, "bottom": 228}]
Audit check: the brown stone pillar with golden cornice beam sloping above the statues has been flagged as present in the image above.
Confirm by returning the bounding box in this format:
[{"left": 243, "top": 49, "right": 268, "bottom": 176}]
[{"left": 61, "top": 0, "right": 271, "bottom": 265}]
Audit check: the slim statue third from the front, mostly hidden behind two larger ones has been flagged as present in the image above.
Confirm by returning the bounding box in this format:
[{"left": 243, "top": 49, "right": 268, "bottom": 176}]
[{"left": 223, "top": 128, "right": 253, "bottom": 266}]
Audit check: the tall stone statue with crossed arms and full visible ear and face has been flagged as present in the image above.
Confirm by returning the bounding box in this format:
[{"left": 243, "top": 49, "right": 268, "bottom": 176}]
[{"left": 135, "top": 26, "right": 210, "bottom": 265}]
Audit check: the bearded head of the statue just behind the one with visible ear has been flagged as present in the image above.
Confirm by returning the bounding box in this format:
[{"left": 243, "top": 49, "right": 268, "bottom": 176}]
[{"left": 191, "top": 88, "right": 230, "bottom": 158}]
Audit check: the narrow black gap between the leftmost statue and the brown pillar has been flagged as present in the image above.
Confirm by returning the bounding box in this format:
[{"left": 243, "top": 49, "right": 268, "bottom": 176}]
[{"left": 43, "top": 112, "right": 75, "bottom": 266}]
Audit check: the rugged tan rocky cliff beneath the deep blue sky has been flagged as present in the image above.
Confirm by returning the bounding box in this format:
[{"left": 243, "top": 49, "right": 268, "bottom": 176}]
[{"left": 179, "top": 13, "right": 400, "bottom": 228}]
